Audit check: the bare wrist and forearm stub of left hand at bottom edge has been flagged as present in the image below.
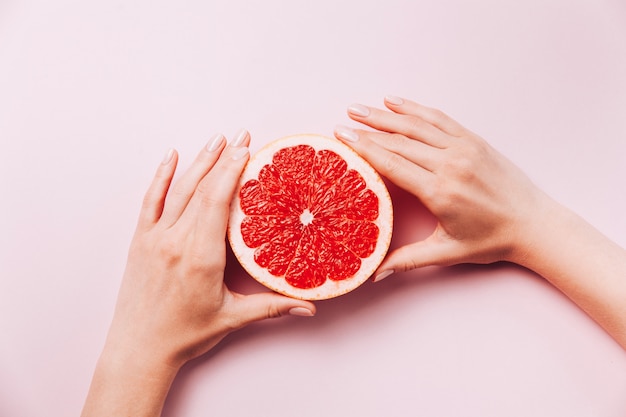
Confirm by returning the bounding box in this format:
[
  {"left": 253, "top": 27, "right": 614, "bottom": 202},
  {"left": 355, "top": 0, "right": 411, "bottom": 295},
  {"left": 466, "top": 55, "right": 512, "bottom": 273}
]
[{"left": 81, "top": 348, "right": 178, "bottom": 417}]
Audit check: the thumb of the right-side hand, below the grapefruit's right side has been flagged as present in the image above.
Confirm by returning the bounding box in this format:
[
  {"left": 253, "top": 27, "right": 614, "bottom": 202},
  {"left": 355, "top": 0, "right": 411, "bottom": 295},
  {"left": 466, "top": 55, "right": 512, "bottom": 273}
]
[{"left": 374, "top": 231, "right": 459, "bottom": 282}]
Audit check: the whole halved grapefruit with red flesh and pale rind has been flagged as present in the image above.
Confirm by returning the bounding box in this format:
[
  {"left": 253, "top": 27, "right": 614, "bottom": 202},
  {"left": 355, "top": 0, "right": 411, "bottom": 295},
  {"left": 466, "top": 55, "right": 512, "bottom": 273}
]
[{"left": 228, "top": 135, "right": 393, "bottom": 300}]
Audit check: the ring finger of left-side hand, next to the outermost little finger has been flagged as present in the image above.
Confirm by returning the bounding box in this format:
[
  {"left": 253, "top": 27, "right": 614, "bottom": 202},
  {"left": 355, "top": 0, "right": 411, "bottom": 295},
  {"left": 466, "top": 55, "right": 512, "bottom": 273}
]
[{"left": 161, "top": 133, "right": 229, "bottom": 227}]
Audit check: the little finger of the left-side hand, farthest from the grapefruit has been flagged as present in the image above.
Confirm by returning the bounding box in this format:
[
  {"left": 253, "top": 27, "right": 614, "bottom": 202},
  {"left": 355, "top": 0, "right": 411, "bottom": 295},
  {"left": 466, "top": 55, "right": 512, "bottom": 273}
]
[{"left": 138, "top": 149, "right": 178, "bottom": 228}]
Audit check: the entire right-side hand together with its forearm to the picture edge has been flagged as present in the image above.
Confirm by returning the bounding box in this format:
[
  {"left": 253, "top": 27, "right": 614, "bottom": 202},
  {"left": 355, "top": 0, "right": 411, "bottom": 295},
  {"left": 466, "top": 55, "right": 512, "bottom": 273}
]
[{"left": 335, "top": 97, "right": 626, "bottom": 348}]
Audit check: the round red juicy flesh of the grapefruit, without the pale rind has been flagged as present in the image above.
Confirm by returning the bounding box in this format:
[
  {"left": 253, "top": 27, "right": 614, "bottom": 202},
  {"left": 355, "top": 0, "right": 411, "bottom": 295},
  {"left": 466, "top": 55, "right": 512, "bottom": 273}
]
[{"left": 239, "top": 145, "right": 379, "bottom": 289}]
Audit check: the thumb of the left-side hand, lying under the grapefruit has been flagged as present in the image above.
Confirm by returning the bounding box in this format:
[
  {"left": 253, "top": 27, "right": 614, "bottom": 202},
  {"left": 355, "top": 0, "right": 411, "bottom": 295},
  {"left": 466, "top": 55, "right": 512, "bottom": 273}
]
[{"left": 229, "top": 292, "right": 316, "bottom": 327}]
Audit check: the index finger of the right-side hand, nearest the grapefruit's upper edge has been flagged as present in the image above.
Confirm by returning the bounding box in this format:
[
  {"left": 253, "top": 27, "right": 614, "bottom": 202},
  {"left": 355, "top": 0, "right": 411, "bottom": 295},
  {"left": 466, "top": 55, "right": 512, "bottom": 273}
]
[{"left": 335, "top": 126, "right": 434, "bottom": 194}]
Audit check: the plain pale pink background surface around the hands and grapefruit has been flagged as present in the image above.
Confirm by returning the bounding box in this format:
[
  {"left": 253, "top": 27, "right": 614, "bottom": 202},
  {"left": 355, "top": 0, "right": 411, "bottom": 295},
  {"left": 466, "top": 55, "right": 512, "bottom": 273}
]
[{"left": 0, "top": 0, "right": 626, "bottom": 417}]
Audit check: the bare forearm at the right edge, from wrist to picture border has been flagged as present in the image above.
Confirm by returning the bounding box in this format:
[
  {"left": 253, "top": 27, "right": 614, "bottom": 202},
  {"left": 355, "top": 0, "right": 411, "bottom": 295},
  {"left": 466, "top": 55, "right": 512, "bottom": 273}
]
[{"left": 512, "top": 197, "right": 626, "bottom": 349}]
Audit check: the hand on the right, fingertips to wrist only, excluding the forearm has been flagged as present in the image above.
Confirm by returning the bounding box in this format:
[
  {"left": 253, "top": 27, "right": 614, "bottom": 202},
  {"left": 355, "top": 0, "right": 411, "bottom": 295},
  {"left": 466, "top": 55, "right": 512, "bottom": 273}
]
[{"left": 335, "top": 97, "right": 547, "bottom": 280}]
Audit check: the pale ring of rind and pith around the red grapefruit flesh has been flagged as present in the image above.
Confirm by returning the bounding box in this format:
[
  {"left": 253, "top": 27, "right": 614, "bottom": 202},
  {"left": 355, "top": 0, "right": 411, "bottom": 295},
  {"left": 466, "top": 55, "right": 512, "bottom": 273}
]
[{"left": 228, "top": 134, "right": 393, "bottom": 300}]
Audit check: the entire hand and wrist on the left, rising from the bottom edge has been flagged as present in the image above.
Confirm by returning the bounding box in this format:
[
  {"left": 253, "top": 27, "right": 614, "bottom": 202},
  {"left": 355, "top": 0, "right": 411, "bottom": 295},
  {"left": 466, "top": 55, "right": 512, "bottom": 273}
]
[{"left": 83, "top": 131, "right": 315, "bottom": 416}]
